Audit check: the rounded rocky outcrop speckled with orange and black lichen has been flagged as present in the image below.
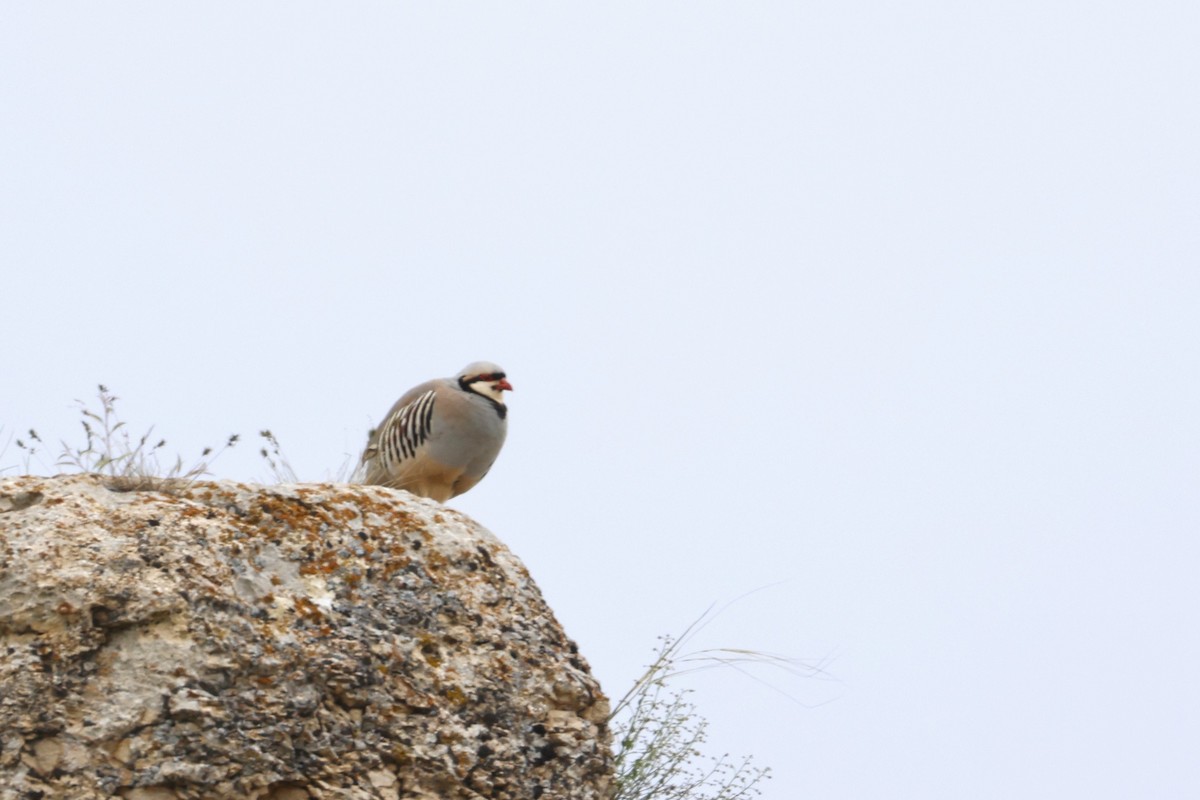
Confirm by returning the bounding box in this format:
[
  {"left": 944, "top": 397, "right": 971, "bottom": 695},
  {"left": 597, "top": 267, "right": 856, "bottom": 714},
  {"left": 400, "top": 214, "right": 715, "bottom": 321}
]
[{"left": 0, "top": 475, "right": 611, "bottom": 800}]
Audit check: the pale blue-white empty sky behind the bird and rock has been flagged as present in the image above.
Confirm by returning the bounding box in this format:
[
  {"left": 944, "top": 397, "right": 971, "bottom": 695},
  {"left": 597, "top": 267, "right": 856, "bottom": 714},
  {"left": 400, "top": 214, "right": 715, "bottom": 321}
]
[{"left": 0, "top": 0, "right": 1200, "bottom": 800}]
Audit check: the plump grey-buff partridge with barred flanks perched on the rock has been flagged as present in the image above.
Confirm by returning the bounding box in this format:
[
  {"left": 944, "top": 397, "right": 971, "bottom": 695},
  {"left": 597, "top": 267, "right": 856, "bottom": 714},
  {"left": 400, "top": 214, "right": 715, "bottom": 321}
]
[{"left": 360, "top": 361, "right": 512, "bottom": 503}]
